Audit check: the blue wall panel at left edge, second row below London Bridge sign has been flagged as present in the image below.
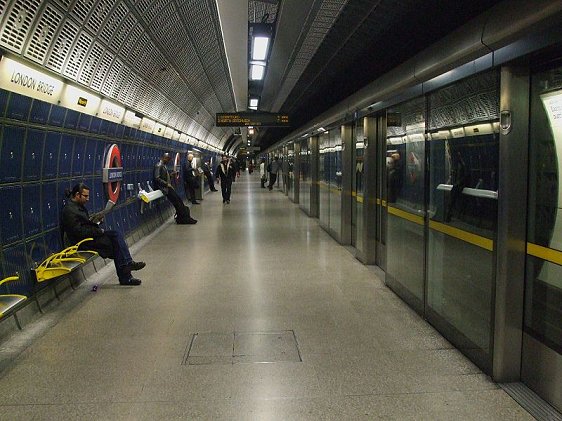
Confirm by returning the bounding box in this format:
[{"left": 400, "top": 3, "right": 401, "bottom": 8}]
[{"left": 0, "top": 126, "right": 25, "bottom": 183}]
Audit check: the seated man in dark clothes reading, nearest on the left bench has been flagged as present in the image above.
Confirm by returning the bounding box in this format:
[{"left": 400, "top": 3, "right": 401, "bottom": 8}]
[{"left": 62, "top": 183, "right": 146, "bottom": 285}]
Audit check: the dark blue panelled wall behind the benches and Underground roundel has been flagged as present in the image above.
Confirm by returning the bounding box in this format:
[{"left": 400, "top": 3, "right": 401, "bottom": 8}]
[{"left": 0, "top": 90, "right": 206, "bottom": 294}]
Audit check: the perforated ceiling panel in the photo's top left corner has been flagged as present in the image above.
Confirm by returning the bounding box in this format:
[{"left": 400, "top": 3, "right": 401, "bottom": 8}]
[{"left": 0, "top": 0, "right": 41, "bottom": 53}]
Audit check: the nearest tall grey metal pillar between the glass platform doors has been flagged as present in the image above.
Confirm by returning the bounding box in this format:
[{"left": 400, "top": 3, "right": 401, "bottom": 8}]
[{"left": 492, "top": 67, "right": 529, "bottom": 382}]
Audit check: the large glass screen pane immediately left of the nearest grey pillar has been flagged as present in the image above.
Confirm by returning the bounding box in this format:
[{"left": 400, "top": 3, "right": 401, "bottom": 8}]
[{"left": 427, "top": 72, "right": 499, "bottom": 369}]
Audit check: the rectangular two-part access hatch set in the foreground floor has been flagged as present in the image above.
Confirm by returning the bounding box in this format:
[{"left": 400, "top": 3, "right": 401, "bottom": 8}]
[{"left": 182, "top": 330, "right": 302, "bottom": 365}]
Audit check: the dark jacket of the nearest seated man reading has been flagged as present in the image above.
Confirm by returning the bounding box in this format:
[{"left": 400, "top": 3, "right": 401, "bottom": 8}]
[{"left": 61, "top": 200, "right": 114, "bottom": 259}]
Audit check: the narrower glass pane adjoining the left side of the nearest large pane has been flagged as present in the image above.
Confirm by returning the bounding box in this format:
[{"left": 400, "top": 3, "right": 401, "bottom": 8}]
[{"left": 386, "top": 98, "right": 425, "bottom": 307}]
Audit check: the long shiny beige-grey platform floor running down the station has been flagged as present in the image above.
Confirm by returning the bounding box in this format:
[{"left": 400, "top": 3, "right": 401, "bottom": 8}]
[{"left": 0, "top": 175, "right": 531, "bottom": 420}]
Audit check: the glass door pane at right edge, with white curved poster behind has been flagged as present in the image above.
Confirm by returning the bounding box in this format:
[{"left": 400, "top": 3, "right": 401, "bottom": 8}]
[{"left": 525, "top": 66, "right": 562, "bottom": 354}]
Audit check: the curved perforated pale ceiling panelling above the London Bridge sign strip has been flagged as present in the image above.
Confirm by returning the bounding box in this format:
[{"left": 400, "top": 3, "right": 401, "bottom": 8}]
[{"left": 0, "top": 0, "right": 238, "bottom": 148}]
